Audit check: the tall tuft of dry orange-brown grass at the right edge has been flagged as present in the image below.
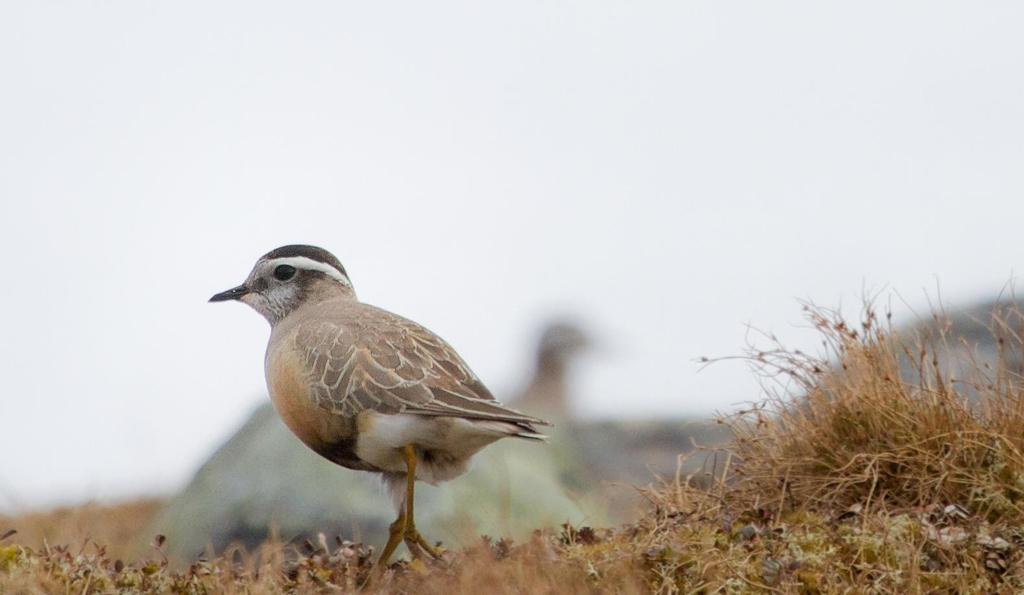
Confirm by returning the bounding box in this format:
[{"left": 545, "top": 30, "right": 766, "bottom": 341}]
[{"left": 729, "top": 306, "right": 1024, "bottom": 522}]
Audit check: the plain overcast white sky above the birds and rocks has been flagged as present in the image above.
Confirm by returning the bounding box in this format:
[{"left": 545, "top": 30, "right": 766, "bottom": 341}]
[{"left": 0, "top": 0, "right": 1024, "bottom": 508}]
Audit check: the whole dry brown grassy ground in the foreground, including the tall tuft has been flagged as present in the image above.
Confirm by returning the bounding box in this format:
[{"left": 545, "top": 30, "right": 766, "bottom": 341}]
[{"left": 6, "top": 308, "right": 1024, "bottom": 595}]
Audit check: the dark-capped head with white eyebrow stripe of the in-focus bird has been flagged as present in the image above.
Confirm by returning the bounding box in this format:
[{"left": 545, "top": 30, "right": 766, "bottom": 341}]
[{"left": 210, "top": 245, "right": 355, "bottom": 325}]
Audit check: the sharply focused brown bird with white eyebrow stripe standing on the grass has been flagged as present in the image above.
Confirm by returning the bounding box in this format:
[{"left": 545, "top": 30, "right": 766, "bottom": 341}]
[{"left": 202, "top": 245, "right": 551, "bottom": 567}]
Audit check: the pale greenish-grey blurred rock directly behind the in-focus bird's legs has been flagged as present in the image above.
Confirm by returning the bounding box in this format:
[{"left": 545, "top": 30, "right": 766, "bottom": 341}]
[{"left": 146, "top": 403, "right": 585, "bottom": 558}]
